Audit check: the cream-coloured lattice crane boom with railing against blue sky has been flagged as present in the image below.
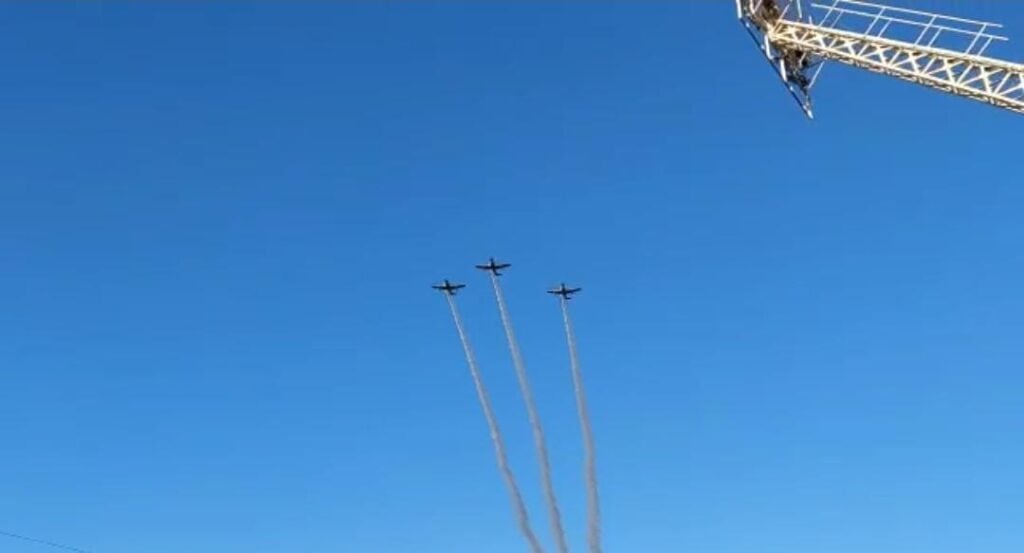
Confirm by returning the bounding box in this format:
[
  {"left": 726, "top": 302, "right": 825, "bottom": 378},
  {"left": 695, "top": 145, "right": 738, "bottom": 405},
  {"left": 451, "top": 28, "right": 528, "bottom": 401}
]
[{"left": 736, "top": 0, "right": 1024, "bottom": 118}]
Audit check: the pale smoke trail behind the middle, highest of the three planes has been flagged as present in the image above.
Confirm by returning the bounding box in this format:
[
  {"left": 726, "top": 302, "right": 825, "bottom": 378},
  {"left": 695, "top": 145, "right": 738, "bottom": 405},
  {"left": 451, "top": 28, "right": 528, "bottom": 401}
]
[{"left": 490, "top": 272, "right": 569, "bottom": 553}]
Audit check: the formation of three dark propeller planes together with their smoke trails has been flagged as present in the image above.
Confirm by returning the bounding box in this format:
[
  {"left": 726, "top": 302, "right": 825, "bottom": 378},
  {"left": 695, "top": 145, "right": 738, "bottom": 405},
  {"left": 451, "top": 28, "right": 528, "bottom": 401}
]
[{"left": 433, "top": 257, "right": 601, "bottom": 553}]
